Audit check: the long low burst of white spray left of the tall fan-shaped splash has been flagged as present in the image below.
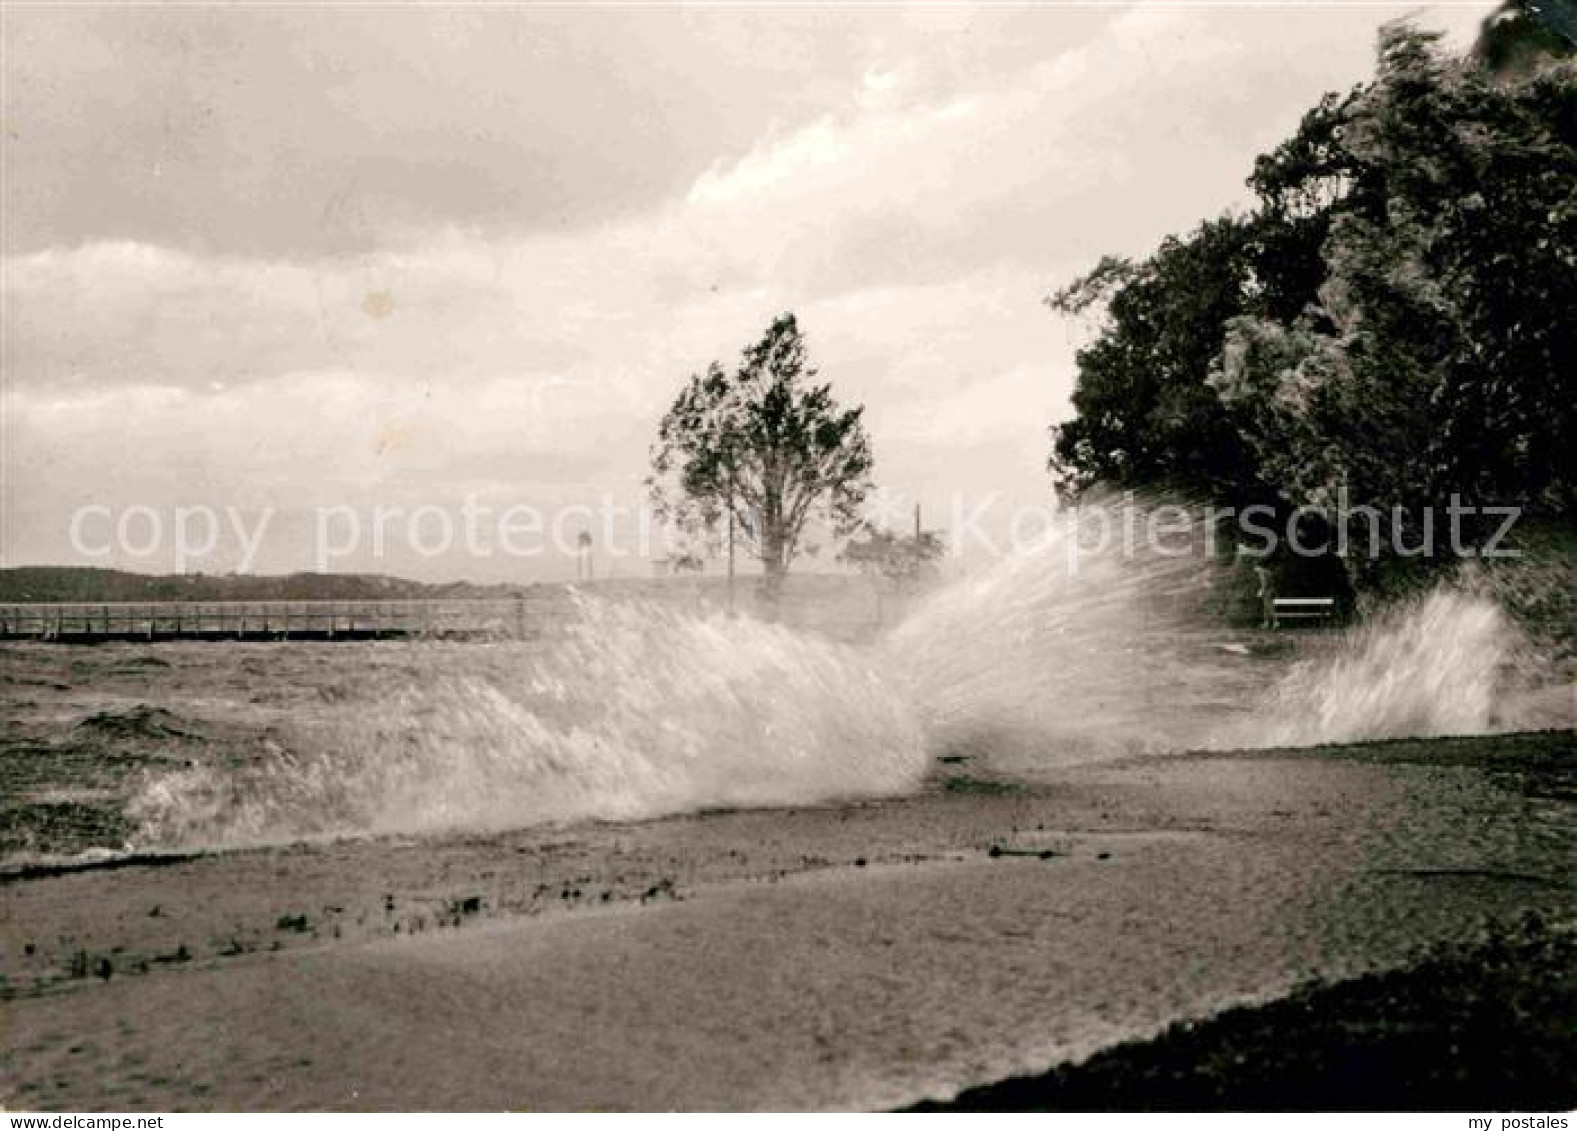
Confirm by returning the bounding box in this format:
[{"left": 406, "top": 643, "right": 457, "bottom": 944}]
[{"left": 134, "top": 599, "right": 926, "bottom": 844}]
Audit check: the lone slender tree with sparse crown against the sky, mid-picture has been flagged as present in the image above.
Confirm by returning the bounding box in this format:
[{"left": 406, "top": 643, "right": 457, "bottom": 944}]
[{"left": 648, "top": 314, "right": 872, "bottom": 582}]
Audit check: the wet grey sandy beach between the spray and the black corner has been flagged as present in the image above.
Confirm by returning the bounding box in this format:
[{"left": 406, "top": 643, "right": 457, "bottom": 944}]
[{"left": 0, "top": 732, "right": 1577, "bottom": 1110}]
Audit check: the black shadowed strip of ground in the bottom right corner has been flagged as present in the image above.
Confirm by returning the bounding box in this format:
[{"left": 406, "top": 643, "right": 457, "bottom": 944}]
[{"left": 905, "top": 916, "right": 1577, "bottom": 1112}]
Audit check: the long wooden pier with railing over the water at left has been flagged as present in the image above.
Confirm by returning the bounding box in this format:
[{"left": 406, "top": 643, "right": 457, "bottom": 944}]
[{"left": 0, "top": 598, "right": 530, "bottom": 644}]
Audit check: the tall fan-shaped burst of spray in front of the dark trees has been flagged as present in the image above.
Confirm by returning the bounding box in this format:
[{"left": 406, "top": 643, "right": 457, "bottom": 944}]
[{"left": 883, "top": 500, "right": 1266, "bottom": 770}]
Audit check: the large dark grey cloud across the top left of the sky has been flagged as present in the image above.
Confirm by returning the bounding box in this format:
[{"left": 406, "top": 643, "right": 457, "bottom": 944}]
[{"left": 3, "top": 5, "right": 902, "bottom": 257}]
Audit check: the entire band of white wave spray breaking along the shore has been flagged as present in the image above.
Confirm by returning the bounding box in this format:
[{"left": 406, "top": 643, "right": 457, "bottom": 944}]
[{"left": 131, "top": 505, "right": 1577, "bottom": 845}]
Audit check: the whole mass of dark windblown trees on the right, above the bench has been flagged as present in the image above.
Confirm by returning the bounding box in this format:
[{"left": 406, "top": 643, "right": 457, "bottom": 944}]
[{"left": 1049, "top": 16, "right": 1577, "bottom": 577}]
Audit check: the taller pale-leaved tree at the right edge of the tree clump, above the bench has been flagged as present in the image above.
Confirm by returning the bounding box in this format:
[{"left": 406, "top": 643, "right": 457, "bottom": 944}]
[{"left": 1208, "top": 19, "right": 1577, "bottom": 544}]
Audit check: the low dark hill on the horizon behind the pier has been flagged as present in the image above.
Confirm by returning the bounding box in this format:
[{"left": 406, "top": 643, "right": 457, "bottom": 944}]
[{"left": 0, "top": 566, "right": 528, "bottom": 601}]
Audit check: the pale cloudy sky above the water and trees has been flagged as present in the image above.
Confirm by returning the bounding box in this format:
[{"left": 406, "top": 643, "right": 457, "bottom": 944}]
[{"left": 0, "top": 2, "right": 1492, "bottom": 580}]
